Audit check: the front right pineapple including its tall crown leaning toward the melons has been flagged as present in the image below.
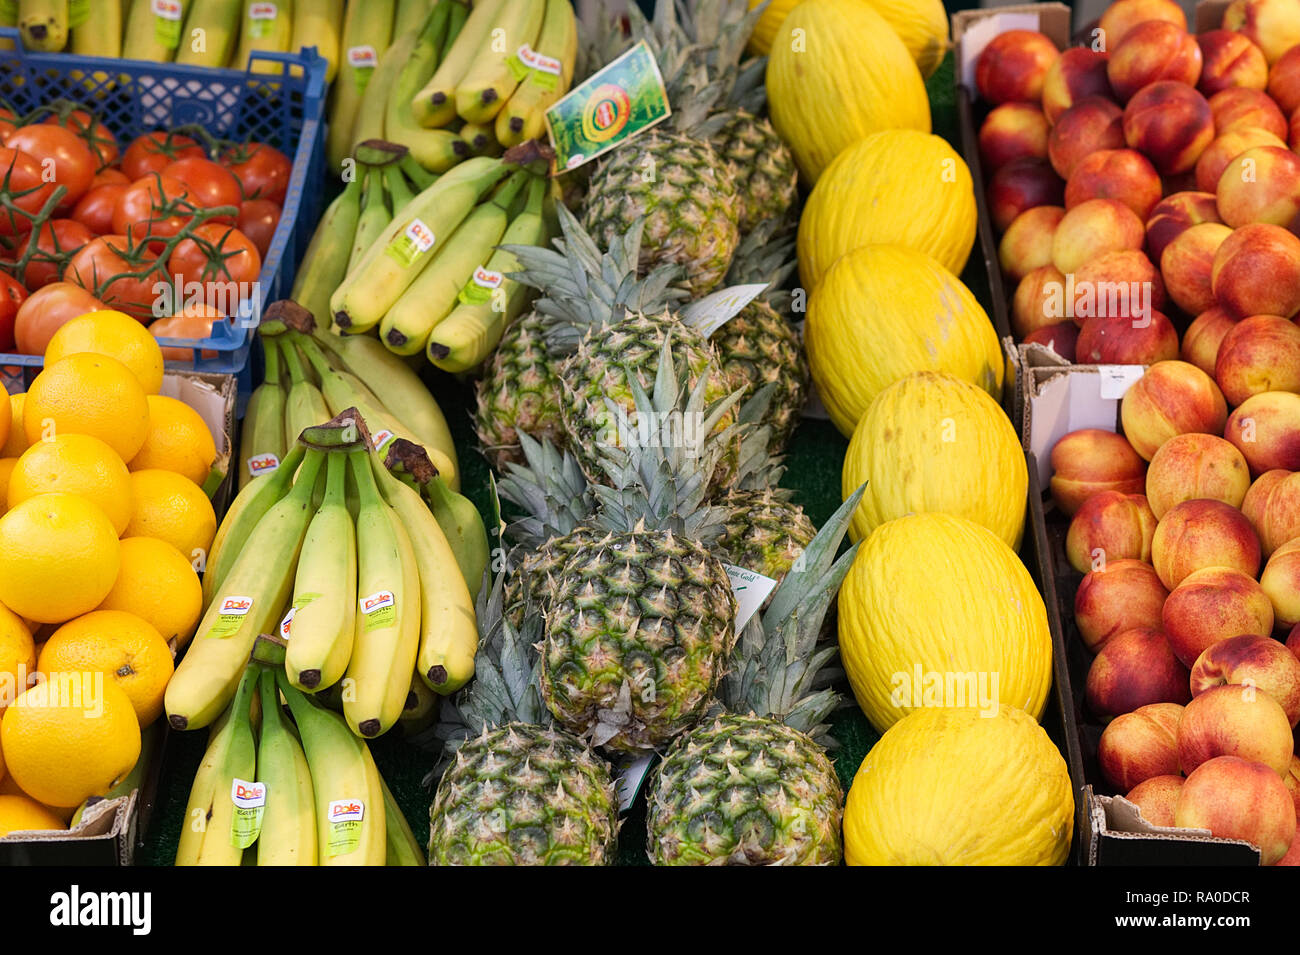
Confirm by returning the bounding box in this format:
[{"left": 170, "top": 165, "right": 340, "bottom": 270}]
[{"left": 646, "top": 490, "right": 862, "bottom": 865}]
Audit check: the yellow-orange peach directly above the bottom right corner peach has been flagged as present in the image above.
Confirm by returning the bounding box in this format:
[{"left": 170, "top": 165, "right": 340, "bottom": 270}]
[{"left": 1178, "top": 686, "right": 1295, "bottom": 779}]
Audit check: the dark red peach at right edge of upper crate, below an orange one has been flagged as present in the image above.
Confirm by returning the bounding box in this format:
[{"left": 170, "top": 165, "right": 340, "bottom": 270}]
[{"left": 1206, "top": 223, "right": 1300, "bottom": 318}]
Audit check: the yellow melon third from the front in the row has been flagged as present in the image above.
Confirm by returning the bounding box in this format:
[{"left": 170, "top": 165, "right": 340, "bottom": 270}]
[{"left": 841, "top": 372, "right": 1030, "bottom": 550}]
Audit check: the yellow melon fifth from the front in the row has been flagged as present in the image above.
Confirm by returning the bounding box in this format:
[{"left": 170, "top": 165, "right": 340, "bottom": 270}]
[{"left": 798, "top": 130, "right": 978, "bottom": 291}]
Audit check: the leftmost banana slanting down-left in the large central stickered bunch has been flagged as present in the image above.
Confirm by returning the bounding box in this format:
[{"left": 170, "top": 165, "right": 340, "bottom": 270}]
[{"left": 164, "top": 450, "right": 325, "bottom": 730}]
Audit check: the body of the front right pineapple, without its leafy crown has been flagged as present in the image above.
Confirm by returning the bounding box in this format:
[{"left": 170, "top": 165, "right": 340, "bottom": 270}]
[{"left": 646, "top": 713, "right": 844, "bottom": 865}]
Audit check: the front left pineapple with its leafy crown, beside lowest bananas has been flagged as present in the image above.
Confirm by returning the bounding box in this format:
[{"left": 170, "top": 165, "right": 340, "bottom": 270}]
[{"left": 429, "top": 577, "right": 619, "bottom": 865}]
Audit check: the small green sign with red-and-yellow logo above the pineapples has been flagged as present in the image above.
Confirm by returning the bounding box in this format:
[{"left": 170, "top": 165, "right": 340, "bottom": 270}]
[{"left": 546, "top": 40, "right": 672, "bottom": 170}]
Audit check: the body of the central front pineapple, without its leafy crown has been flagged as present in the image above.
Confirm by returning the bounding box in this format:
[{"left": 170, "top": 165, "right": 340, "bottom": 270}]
[{"left": 541, "top": 528, "right": 736, "bottom": 752}]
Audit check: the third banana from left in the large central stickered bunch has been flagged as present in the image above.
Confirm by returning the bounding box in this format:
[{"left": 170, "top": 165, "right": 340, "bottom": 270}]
[{"left": 343, "top": 451, "right": 420, "bottom": 737}]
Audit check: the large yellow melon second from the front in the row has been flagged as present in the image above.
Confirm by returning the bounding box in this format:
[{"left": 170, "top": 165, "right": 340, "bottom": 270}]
[{"left": 840, "top": 513, "right": 1052, "bottom": 732}]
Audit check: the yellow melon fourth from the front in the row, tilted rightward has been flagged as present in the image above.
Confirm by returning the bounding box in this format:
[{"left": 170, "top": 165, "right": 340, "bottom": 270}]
[{"left": 803, "top": 246, "right": 1006, "bottom": 437}]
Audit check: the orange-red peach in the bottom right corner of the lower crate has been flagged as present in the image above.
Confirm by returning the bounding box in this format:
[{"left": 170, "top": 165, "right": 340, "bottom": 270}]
[{"left": 1174, "top": 755, "right": 1296, "bottom": 865}]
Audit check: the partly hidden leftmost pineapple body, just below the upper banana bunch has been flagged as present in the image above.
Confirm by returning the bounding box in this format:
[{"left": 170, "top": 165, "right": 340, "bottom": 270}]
[{"left": 475, "top": 312, "right": 564, "bottom": 472}]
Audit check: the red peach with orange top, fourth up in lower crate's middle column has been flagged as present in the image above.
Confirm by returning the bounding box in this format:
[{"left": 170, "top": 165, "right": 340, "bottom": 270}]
[{"left": 1161, "top": 567, "right": 1273, "bottom": 667}]
